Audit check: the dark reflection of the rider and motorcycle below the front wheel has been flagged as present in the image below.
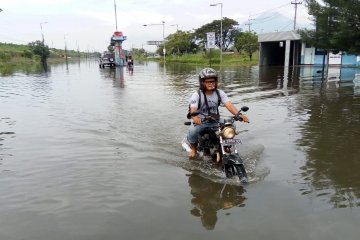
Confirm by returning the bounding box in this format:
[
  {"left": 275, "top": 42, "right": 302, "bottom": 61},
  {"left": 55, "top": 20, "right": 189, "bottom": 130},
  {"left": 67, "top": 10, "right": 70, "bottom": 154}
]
[{"left": 188, "top": 173, "right": 246, "bottom": 230}]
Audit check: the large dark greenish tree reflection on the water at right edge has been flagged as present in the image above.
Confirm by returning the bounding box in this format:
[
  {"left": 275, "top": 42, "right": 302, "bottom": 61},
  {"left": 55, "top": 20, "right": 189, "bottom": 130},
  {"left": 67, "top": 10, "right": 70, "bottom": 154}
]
[{"left": 298, "top": 80, "right": 360, "bottom": 207}]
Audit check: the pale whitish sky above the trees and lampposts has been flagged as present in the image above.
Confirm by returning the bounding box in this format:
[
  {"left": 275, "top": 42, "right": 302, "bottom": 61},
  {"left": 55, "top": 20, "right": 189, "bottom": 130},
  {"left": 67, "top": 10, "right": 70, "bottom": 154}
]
[{"left": 0, "top": 0, "right": 311, "bottom": 52}]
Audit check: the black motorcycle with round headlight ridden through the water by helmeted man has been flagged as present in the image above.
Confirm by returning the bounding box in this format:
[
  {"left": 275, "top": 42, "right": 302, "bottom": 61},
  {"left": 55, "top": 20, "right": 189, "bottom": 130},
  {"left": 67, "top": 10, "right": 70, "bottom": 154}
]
[{"left": 182, "top": 106, "right": 249, "bottom": 184}]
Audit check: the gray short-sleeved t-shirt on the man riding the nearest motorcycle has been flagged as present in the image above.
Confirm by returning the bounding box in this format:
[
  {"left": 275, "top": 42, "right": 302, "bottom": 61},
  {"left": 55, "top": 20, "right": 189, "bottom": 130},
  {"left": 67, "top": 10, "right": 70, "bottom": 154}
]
[{"left": 190, "top": 89, "right": 229, "bottom": 119}]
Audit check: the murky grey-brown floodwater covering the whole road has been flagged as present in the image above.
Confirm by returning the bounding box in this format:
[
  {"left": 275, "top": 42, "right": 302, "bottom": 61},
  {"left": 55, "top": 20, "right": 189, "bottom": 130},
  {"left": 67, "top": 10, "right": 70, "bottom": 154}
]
[{"left": 0, "top": 61, "right": 360, "bottom": 240}]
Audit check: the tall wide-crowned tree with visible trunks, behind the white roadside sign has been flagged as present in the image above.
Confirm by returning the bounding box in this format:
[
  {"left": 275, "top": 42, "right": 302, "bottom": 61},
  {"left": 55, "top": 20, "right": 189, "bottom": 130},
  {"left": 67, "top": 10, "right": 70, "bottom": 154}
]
[{"left": 194, "top": 17, "right": 241, "bottom": 51}]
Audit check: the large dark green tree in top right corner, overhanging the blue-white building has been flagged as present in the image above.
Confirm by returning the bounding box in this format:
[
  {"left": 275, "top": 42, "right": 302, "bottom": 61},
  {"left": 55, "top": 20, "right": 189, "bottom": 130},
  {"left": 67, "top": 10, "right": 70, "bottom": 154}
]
[{"left": 299, "top": 0, "right": 360, "bottom": 54}]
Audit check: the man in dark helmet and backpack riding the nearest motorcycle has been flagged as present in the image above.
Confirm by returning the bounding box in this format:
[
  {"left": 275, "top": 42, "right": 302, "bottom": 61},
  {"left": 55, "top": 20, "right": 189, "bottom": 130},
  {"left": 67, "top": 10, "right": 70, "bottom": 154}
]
[{"left": 187, "top": 68, "right": 249, "bottom": 159}]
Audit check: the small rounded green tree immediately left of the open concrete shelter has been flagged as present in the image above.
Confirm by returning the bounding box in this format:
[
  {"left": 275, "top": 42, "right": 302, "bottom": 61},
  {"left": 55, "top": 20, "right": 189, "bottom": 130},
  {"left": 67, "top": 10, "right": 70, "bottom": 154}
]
[{"left": 235, "top": 32, "right": 259, "bottom": 61}]
